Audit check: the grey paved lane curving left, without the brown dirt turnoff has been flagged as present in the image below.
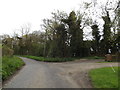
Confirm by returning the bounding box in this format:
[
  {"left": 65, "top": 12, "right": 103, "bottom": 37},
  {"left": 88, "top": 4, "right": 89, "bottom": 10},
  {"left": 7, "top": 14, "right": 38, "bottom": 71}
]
[{"left": 3, "top": 57, "right": 79, "bottom": 88}]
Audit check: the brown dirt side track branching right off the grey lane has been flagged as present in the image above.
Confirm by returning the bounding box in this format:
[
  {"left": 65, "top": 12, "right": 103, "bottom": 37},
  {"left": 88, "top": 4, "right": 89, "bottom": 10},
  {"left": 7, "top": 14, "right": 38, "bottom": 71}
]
[{"left": 49, "top": 59, "right": 118, "bottom": 88}]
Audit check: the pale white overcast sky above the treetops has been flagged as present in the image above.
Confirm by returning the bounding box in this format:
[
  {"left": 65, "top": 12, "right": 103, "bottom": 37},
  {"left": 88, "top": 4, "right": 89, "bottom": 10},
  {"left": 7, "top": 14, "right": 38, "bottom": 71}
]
[{"left": 0, "top": 0, "right": 117, "bottom": 35}]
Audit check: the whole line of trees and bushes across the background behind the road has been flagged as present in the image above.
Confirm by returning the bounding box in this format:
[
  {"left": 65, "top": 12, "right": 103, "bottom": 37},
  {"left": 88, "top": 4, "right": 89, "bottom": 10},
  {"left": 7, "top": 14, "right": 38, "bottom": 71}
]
[{"left": 2, "top": 8, "right": 120, "bottom": 57}]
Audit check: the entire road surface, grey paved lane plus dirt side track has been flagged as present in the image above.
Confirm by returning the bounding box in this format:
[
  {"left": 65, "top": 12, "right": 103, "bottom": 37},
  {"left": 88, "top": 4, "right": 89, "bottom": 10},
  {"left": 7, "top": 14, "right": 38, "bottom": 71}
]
[{"left": 3, "top": 57, "right": 118, "bottom": 88}]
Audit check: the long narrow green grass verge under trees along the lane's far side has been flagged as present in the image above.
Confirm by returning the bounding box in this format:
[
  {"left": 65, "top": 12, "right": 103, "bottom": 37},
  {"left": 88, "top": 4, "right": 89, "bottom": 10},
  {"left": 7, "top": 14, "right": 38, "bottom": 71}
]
[{"left": 23, "top": 55, "right": 75, "bottom": 62}]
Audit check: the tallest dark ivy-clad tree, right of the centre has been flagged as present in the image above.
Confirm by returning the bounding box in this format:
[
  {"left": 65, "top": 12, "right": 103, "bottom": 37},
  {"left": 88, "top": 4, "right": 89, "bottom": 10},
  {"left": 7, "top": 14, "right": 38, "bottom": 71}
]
[{"left": 63, "top": 11, "right": 84, "bottom": 57}]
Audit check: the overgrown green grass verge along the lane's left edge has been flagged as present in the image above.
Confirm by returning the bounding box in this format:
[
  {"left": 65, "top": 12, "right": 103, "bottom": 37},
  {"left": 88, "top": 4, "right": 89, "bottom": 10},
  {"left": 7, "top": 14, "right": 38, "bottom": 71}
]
[{"left": 0, "top": 56, "right": 24, "bottom": 80}]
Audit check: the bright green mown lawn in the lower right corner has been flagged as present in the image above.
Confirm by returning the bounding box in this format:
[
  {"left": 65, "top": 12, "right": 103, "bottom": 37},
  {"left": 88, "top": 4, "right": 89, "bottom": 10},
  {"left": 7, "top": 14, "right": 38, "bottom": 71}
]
[{"left": 89, "top": 67, "right": 120, "bottom": 88}]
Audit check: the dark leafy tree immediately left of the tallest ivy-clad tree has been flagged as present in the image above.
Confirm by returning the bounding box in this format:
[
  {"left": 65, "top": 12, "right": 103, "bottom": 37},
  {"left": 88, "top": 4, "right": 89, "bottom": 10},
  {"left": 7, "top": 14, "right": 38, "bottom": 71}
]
[{"left": 48, "top": 24, "right": 67, "bottom": 57}]
